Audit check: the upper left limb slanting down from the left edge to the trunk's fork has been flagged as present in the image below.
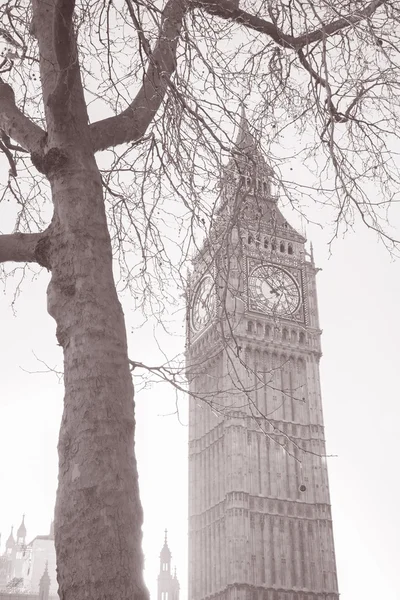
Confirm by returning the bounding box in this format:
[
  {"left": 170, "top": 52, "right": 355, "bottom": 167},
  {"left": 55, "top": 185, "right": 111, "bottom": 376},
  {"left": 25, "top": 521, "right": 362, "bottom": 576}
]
[{"left": 0, "top": 79, "right": 46, "bottom": 152}]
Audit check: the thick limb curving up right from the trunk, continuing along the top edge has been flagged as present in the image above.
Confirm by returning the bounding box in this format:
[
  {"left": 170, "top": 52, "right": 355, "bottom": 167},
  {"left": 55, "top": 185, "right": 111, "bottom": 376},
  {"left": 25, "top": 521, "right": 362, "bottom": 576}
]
[{"left": 90, "top": 0, "right": 388, "bottom": 152}]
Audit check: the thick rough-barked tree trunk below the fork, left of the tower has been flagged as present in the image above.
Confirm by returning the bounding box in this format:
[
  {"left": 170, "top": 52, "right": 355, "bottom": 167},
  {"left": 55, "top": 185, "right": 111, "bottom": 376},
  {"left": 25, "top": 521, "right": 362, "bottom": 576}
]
[{"left": 48, "top": 156, "right": 147, "bottom": 600}]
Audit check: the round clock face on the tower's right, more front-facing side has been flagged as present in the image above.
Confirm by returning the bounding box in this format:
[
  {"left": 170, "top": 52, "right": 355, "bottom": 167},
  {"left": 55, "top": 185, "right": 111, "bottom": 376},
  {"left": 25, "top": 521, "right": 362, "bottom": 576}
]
[{"left": 249, "top": 265, "right": 301, "bottom": 317}]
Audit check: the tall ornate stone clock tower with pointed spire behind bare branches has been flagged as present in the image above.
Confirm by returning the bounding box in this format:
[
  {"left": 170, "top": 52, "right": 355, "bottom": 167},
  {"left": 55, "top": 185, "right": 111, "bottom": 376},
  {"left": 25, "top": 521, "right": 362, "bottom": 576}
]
[{"left": 186, "top": 108, "right": 339, "bottom": 600}]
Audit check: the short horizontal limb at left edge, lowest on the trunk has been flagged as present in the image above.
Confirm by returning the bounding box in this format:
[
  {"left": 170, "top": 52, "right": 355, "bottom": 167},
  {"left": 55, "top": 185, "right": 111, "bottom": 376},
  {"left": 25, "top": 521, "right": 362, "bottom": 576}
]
[{"left": 0, "top": 230, "right": 49, "bottom": 268}]
